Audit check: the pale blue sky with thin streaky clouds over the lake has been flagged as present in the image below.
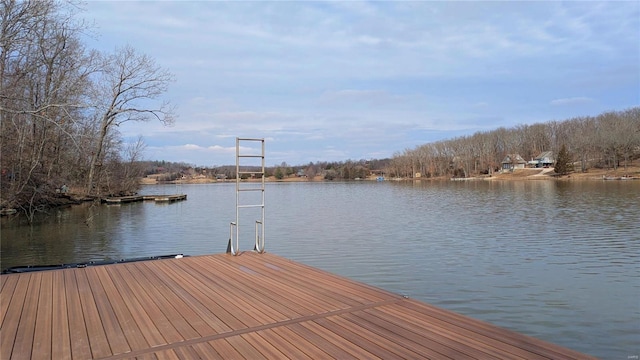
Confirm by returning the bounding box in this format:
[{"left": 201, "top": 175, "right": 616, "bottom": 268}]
[{"left": 82, "top": 1, "right": 640, "bottom": 166}]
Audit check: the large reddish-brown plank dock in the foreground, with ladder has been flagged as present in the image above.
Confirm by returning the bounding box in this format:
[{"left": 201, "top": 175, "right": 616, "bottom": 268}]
[{"left": 0, "top": 252, "right": 590, "bottom": 359}]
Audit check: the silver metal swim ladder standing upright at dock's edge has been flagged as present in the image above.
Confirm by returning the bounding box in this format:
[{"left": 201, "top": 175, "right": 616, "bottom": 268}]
[{"left": 227, "top": 137, "right": 265, "bottom": 255}]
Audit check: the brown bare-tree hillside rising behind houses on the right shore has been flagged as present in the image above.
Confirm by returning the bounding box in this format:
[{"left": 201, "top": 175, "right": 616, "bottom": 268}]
[{"left": 387, "top": 107, "right": 640, "bottom": 177}]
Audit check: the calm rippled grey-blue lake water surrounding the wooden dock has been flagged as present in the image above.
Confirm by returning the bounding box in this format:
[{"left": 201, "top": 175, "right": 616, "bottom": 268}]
[{"left": 0, "top": 181, "right": 640, "bottom": 359}]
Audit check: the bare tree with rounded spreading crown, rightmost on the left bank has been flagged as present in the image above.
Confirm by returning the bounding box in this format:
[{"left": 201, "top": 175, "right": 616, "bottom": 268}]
[{"left": 86, "top": 46, "right": 174, "bottom": 194}]
